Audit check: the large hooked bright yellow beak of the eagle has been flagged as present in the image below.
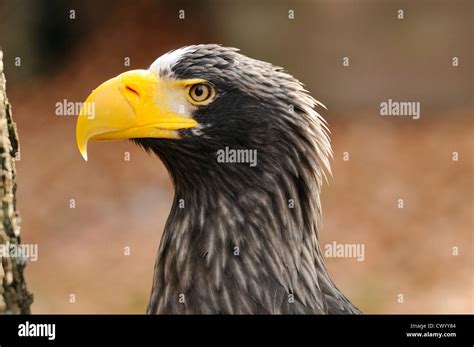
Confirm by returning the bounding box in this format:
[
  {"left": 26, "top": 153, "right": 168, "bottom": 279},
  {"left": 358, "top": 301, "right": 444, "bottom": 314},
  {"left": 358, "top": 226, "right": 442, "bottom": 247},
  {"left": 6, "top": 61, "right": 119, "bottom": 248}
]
[{"left": 76, "top": 70, "right": 198, "bottom": 160}]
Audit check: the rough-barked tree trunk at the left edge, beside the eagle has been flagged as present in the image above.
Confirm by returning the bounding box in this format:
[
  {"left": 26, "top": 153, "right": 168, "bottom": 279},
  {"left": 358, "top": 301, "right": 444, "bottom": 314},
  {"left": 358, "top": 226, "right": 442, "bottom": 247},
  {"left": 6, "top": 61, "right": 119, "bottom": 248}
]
[{"left": 0, "top": 50, "right": 33, "bottom": 314}]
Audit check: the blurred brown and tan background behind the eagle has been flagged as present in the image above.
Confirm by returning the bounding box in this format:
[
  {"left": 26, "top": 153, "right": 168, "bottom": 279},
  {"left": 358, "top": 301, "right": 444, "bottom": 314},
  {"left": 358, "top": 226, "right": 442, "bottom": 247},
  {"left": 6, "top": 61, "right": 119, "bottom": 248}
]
[{"left": 0, "top": 0, "right": 474, "bottom": 313}]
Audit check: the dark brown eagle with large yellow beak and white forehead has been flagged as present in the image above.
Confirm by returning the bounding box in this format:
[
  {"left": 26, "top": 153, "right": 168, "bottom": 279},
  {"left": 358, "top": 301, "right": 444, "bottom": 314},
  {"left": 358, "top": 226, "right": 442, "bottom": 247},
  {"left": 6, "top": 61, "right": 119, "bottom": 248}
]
[{"left": 76, "top": 44, "right": 361, "bottom": 314}]
